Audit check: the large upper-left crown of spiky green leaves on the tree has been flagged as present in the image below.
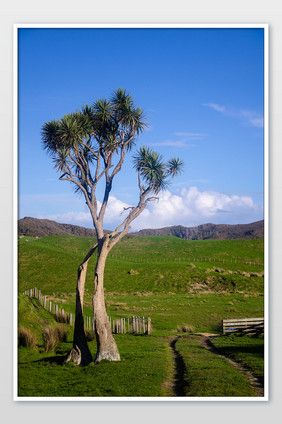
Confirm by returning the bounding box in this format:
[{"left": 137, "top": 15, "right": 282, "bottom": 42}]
[{"left": 41, "top": 88, "right": 147, "bottom": 177}]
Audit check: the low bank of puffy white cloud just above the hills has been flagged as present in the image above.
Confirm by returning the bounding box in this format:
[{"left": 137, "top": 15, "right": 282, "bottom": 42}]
[{"left": 38, "top": 187, "right": 263, "bottom": 231}]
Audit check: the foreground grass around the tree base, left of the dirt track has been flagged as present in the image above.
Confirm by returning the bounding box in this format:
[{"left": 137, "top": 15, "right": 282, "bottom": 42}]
[{"left": 18, "top": 335, "right": 171, "bottom": 397}]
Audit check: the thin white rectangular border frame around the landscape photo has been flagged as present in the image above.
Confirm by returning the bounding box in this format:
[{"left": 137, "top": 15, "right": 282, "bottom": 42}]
[{"left": 13, "top": 23, "right": 269, "bottom": 402}]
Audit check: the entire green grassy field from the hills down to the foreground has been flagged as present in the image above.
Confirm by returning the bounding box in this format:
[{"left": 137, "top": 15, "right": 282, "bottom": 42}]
[{"left": 18, "top": 236, "right": 264, "bottom": 397}]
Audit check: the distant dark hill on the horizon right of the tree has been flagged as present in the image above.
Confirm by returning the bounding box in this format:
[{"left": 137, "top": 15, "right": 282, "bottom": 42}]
[{"left": 134, "top": 220, "right": 264, "bottom": 240}]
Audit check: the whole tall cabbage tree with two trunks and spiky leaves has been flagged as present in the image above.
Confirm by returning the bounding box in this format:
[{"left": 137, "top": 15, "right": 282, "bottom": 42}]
[{"left": 42, "top": 88, "right": 183, "bottom": 365}]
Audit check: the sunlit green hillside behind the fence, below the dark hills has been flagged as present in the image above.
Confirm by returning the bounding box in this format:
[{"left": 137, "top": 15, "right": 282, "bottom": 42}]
[{"left": 19, "top": 236, "right": 263, "bottom": 294}]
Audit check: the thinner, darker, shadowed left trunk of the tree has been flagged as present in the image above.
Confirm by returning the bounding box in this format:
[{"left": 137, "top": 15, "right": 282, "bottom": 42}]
[{"left": 65, "top": 258, "right": 93, "bottom": 365}]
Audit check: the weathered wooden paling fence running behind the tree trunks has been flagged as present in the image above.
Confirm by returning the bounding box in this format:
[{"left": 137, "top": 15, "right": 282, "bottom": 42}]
[{"left": 23, "top": 287, "right": 152, "bottom": 335}]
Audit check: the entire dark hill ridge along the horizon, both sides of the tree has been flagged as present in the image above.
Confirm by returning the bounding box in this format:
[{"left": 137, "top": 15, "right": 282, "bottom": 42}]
[{"left": 18, "top": 217, "right": 264, "bottom": 240}]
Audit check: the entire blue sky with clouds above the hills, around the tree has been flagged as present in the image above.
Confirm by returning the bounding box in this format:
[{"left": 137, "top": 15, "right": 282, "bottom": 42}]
[{"left": 18, "top": 28, "right": 264, "bottom": 230}]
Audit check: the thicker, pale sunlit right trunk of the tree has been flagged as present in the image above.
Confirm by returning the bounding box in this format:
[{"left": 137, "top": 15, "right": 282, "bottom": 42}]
[{"left": 93, "top": 241, "right": 120, "bottom": 364}]
